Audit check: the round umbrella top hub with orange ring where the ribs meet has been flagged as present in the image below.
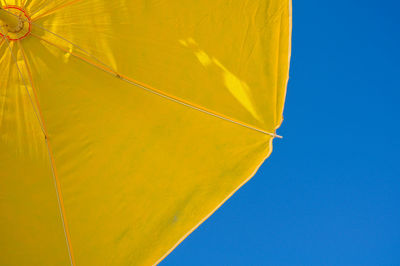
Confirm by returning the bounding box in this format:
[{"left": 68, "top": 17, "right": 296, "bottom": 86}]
[{"left": 0, "top": 5, "right": 31, "bottom": 41}]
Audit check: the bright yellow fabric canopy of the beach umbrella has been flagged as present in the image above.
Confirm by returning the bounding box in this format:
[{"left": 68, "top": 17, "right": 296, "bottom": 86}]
[{"left": 0, "top": 0, "right": 291, "bottom": 265}]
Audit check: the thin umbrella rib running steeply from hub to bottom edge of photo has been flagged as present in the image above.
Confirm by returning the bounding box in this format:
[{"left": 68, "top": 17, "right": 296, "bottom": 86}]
[{"left": 15, "top": 41, "right": 75, "bottom": 266}]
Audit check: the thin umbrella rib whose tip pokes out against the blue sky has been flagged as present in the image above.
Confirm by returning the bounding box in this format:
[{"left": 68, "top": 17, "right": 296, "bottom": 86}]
[{"left": 31, "top": 33, "right": 282, "bottom": 138}]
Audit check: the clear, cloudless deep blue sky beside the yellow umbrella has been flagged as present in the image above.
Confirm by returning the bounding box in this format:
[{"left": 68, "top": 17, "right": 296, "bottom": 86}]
[{"left": 161, "top": 0, "right": 400, "bottom": 265}]
